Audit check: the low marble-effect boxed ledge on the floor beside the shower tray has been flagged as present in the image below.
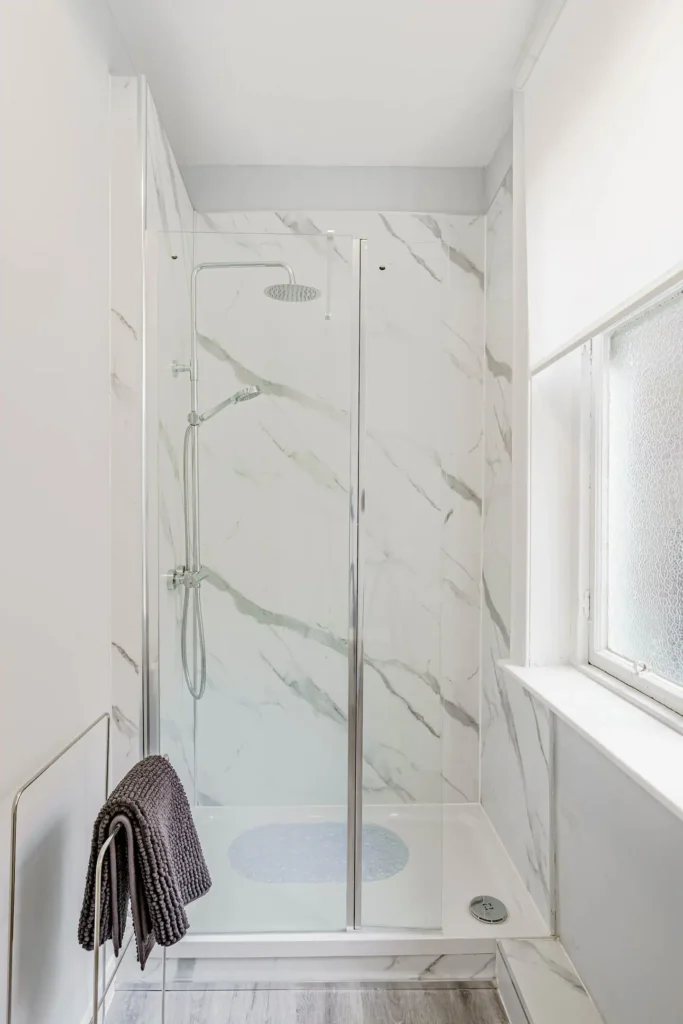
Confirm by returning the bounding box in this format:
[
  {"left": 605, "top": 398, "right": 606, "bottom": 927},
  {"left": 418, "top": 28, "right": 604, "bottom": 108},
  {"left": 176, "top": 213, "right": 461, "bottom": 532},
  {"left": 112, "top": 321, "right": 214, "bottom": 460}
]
[{"left": 499, "top": 939, "right": 602, "bottom": 1024}]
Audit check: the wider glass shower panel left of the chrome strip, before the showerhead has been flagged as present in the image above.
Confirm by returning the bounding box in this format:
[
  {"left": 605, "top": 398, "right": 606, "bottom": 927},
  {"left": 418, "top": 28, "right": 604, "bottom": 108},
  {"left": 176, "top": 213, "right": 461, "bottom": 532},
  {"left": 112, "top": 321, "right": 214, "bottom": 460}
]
[{"left": 159, "top": 231, "right": 357, "bottom": 933}]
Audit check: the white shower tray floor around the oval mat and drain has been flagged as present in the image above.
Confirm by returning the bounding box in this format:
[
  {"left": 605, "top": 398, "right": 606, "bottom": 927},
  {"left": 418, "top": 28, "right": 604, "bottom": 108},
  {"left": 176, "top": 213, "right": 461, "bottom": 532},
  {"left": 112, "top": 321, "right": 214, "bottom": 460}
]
[{"left": 129, "top": 804, "right": 548, "bottom": 937}]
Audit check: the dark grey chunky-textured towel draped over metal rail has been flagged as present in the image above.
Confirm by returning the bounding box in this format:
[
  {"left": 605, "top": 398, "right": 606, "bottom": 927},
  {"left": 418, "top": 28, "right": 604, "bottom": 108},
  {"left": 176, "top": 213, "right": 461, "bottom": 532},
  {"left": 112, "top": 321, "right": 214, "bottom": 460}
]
[{"left": 78, "top": 755, "right": 211, "bottom": 968}]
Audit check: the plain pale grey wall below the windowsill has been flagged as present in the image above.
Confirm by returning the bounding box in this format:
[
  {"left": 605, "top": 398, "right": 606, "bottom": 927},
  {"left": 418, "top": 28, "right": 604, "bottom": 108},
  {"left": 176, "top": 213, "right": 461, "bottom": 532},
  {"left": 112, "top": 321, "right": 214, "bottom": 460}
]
[{"left": 556, "top": 722, "right": 683, "bottom": 1024}]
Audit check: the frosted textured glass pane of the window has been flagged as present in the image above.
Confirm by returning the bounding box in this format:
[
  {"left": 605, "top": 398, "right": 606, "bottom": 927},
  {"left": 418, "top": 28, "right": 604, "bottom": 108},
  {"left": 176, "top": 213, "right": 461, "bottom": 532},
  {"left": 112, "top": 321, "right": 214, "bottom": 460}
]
[{"left": 607, "top": 294, "right": 683, "bottom": 684}]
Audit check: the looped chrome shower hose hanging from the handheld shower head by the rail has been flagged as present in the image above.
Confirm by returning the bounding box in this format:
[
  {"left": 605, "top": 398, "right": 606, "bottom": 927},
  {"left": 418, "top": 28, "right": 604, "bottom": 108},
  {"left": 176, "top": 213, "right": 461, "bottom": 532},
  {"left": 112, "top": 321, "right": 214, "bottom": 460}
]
[{"left": 180, "top": 424, "right": 206, "bottom": 700}]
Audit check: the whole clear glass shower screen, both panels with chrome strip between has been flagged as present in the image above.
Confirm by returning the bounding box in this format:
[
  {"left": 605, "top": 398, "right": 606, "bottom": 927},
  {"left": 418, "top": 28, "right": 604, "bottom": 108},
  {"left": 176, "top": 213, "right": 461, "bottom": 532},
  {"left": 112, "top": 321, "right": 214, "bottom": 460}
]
[{"left": 147, "top": 230, "right": 443, "bottom": 935}]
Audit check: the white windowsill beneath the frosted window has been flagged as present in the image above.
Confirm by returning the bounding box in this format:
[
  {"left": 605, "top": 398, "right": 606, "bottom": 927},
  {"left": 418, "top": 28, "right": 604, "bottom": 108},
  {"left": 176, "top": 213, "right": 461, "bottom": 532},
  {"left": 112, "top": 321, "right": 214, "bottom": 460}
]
[{"left": 500, "top": 662, "right": 683, "bottom": 820}]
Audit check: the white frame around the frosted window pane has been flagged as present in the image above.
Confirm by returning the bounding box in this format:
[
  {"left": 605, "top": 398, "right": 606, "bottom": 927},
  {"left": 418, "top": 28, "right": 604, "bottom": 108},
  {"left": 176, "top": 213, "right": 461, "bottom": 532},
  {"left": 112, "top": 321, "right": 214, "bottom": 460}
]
[{"left": 587, "top": 284, "right": 683, "bottom": 715}]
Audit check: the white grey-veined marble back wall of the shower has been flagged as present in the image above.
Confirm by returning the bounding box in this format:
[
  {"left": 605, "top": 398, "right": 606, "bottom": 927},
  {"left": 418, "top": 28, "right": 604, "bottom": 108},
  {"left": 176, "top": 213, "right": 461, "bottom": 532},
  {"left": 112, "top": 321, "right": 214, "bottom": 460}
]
[{"left": 161, "top": 213, "right": 484, "bottom": 805}]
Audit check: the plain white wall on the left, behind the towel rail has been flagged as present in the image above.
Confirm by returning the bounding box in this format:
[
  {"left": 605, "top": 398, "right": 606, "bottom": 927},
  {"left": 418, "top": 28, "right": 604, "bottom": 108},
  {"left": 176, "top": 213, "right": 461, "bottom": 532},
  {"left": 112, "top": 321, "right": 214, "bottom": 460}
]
[{"left": 0, "top": 0, "right": 129, "bottom": 1024}]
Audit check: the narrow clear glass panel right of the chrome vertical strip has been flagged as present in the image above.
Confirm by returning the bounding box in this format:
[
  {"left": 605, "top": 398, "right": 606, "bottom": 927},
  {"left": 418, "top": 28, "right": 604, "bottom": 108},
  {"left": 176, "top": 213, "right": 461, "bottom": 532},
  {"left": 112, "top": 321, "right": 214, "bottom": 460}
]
[{"left": 360, "top": 232, "right": 450, "bottom": 930}]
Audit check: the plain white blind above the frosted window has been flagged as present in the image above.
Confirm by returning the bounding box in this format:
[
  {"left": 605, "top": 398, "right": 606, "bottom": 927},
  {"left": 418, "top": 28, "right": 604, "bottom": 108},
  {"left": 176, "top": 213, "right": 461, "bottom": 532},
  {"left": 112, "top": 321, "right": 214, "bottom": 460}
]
[{"left": 524, "top": 0, "right": 683, "bottom": 362}]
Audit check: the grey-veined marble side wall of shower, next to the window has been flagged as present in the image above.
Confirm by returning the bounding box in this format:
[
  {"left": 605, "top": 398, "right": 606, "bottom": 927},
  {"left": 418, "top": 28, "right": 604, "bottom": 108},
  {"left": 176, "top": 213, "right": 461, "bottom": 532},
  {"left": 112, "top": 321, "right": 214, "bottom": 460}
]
[{"left": 481, "top": 172, "right": 552, "bottom": 923}]
